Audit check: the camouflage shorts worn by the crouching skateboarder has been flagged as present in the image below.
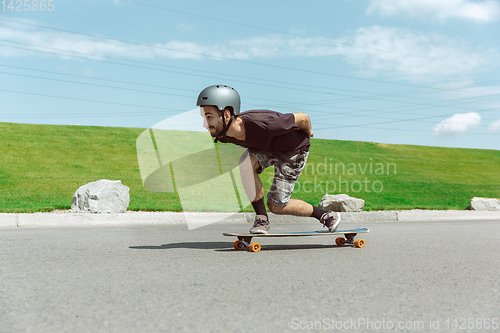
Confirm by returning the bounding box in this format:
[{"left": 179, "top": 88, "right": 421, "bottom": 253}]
[{"left": 245, "top": 148, "right": 309, "bottom": 206}]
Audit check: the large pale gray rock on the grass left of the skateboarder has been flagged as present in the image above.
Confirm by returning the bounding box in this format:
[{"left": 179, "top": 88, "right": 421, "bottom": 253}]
[{"left": 71, "top": 179, "right": 130, "bottom": 213}]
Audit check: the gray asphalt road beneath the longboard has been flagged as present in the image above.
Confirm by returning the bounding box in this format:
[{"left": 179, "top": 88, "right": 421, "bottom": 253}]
[{"left": 0, "top": 221, "right": 500, "bottom": 332}]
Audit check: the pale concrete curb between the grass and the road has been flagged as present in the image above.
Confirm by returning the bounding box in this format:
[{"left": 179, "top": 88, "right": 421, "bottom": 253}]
[{"left": 0, "top": 210, "right": 500, "bottom": 228}]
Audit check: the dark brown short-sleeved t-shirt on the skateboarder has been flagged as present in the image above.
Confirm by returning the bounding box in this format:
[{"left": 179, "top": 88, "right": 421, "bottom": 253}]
[{"left": 219, "top": 110, "right": 311, "bottom": 151}]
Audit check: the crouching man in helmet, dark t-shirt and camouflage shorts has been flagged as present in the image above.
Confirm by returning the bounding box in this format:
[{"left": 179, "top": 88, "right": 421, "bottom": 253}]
[{"left": 197, "top": 85, "right": 340, "bottom": 234}]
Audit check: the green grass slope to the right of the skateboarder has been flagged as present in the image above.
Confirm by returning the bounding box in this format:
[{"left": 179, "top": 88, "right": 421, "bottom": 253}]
[{"left": 290, "top": 140, "right": 500, "bottom": 210}]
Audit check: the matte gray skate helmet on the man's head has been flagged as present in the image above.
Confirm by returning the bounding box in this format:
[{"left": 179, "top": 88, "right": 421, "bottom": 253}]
[{"left": 196, "top": 84, "right": 241, "bottom": 116}]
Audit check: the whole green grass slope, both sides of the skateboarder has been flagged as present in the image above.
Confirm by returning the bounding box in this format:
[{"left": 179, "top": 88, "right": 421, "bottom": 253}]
[{"left": 0, "top": 123, "right": 500, "bottom": 212}]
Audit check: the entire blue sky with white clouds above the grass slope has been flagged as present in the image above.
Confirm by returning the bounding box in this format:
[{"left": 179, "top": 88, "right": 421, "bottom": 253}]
[{"left": 0, "top": 0, "right": 500, "bottom": 150}]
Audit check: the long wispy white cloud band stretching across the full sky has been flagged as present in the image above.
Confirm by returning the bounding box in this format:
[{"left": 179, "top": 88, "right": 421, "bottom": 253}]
[{"left": 0, "top": 24, "right": 499, "bottom": 81}]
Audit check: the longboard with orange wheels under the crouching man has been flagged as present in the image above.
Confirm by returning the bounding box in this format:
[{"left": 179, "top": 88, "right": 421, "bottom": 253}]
[{"left": 223, "top": 228, "right": 370, "bottom": 252}]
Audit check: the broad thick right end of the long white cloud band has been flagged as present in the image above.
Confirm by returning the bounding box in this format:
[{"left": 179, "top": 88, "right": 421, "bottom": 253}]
[{"left": 332, "top": 26, "right": 498, "bottom": 81}]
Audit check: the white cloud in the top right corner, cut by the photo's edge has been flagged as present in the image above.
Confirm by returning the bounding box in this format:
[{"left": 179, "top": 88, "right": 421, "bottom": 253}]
[{"left": 367, "top": 0, "right": 500, "bottom": 22}]
